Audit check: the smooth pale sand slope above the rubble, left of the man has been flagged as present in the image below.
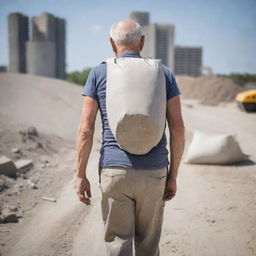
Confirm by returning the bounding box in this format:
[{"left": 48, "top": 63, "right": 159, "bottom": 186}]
[{"left": 0, "top": 73, "right": 83, "bottom": 140}]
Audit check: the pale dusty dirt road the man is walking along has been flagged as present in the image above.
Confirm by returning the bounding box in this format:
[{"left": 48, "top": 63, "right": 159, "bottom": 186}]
[{"left": 0, "top": 73, "right": 256, "bottom": 256}]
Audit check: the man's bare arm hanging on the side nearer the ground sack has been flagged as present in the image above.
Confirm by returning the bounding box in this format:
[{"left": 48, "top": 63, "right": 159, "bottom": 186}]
[{"left": 165, "top": 95, "right": 185, "bottom": 200}]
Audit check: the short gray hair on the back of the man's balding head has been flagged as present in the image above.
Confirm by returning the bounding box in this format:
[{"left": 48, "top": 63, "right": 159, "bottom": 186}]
[{"left": 110, "top": 21, "right": 143, "bottom": 45}]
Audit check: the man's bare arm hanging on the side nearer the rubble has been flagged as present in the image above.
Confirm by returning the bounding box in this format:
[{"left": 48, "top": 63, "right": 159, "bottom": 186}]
[{"left": 76, "top": 96, "right": 98, "bottom": 204}]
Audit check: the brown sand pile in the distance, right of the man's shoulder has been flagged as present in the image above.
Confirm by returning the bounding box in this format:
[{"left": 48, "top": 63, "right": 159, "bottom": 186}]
[{"left": 176, "top": 76, "right": 244, "bottom": 105}]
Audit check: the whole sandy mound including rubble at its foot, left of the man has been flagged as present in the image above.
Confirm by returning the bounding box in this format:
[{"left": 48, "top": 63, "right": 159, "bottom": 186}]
[{"left": 0, "top": 73, "right": 83, "bottom": 224}]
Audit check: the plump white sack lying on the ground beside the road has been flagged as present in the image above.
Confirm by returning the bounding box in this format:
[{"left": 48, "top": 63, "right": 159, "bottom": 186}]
[{"left": 185, "top": 131, "right": 248, "bottom": 164}]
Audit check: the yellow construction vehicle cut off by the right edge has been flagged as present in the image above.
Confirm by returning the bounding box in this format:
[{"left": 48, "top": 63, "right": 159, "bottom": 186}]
[{"left": 236, "top": 90, "right": 256, "bottom": 112}]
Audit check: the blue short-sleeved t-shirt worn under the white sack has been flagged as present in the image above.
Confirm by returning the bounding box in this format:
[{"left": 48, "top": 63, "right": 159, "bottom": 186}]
[{"left": 82, "top": 52, "right": 181, "bottom": 169}]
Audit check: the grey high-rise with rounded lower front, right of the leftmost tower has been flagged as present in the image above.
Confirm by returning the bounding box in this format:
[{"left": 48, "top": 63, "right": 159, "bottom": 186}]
[{"left": 27, "top": 13, "right": 65, "bottom": 79}]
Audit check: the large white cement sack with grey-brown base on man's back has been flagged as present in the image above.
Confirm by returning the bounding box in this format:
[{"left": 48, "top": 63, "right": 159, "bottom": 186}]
[{"left": 106, "top": 57, "right": 166, "bottom": 155}]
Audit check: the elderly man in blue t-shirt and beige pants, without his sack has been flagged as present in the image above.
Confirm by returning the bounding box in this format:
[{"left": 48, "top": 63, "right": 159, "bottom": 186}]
[{"left": 76, "top": 20, "right": 184, "bottom": 256}]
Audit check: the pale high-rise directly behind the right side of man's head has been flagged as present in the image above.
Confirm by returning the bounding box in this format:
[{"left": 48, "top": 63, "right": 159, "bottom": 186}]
[{"left": 130, "top": 12, "right": 174, "bottom": 69}]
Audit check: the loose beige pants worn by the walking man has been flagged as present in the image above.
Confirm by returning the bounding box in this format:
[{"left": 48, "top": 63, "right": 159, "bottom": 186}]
[{"left": 99, "top": 167, "right": 167, "bottom": 256}]
